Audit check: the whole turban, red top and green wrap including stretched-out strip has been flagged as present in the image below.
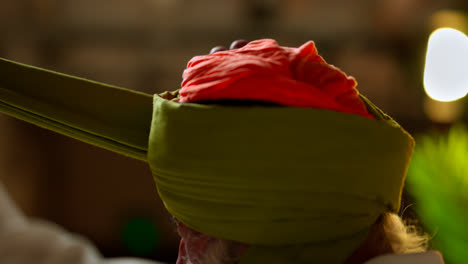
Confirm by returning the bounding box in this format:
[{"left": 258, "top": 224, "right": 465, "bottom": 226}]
[{"left": 0, "top": 40, "right": 414, "bottom": 264}]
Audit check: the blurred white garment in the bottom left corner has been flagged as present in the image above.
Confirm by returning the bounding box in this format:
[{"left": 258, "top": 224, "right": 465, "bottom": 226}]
[{"left": 0, "top": 183, "right": 166, "bottom": 264}]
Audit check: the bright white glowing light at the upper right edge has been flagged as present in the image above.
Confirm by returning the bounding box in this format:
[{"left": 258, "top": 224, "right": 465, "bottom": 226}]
[{"left": 424, "top": 28, "right": 468, "bottom": 102}]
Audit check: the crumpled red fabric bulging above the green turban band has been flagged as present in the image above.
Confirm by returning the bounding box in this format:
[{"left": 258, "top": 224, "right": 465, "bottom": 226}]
[{"left": 180, "top": 39, "right": 373, "bottom": 118}]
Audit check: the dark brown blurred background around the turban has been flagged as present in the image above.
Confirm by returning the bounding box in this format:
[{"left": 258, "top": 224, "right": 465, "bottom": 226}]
[{"left": 0, "top": 0, "right": 468, "bottom": 262}]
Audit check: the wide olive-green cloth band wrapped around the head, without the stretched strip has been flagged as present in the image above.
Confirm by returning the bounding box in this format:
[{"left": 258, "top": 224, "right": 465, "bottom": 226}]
[{"left": 148, "top": 95, "right": 414, "bottom": 263}]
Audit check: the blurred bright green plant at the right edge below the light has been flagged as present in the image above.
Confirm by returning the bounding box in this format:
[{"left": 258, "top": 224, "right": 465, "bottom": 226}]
[{"left": 407, "top": 125, "right": 468, "bottom": 264}]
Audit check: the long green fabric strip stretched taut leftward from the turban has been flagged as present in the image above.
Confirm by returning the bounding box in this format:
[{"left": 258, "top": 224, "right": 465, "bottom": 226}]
[{"left": 0, "top": 58, "right": 152, "bottom": 161}]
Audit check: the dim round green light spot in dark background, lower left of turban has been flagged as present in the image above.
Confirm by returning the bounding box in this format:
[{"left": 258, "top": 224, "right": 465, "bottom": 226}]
[{"left": 122, "top": 218, "right": 160, "bottom": 257}]
